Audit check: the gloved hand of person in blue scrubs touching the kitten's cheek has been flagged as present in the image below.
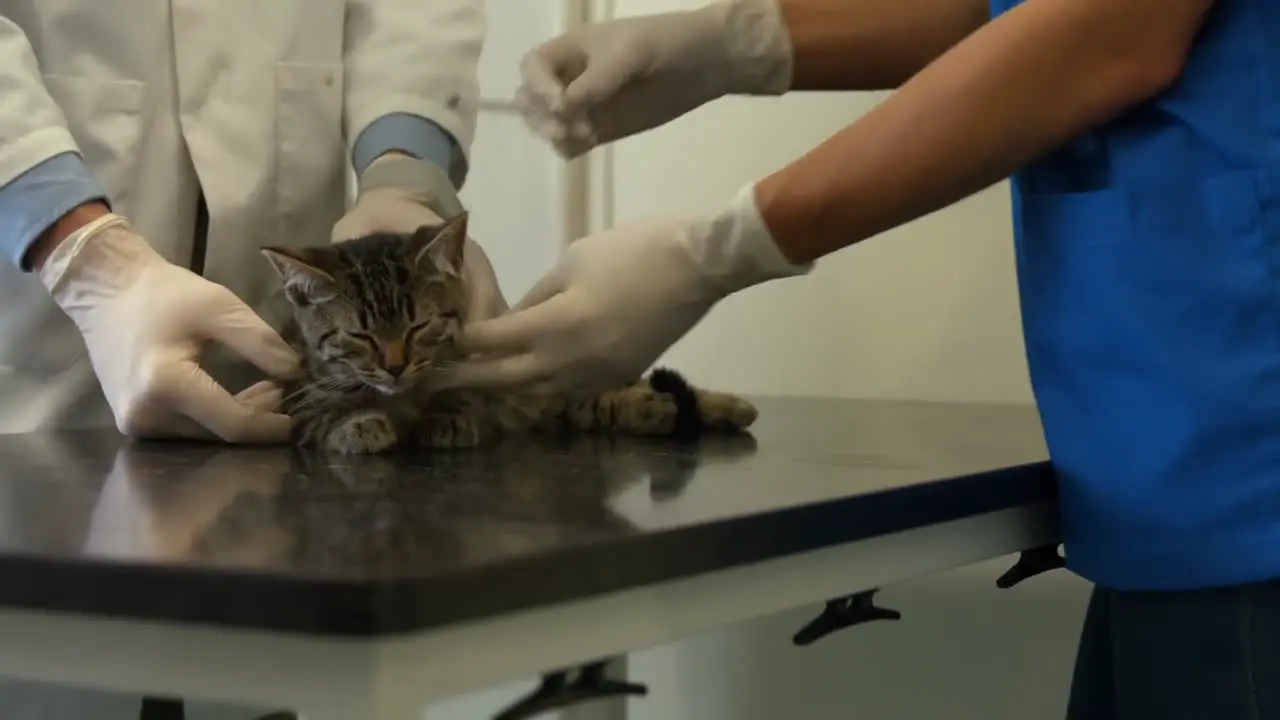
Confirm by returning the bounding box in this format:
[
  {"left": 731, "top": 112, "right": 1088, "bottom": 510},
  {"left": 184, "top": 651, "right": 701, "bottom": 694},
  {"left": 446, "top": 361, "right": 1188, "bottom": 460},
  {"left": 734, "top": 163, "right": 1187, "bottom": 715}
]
[{"left": 443, "top": 181, "right": 812, "bottom": 392}]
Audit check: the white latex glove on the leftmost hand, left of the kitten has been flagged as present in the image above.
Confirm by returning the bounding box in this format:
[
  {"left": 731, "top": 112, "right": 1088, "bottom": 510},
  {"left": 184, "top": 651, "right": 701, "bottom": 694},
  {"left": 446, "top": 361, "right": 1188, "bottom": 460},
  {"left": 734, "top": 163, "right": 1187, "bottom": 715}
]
[{"left": 40, "top": 214, "right": 300, "bottom": 443}]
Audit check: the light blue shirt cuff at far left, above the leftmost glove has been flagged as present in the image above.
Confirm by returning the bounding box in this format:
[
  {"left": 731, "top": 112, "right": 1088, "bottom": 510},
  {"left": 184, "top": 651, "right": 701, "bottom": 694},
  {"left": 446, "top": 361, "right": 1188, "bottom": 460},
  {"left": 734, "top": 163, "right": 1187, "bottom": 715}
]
[{"left": 0, "top": 152, "right": 111, "bottom": 272}]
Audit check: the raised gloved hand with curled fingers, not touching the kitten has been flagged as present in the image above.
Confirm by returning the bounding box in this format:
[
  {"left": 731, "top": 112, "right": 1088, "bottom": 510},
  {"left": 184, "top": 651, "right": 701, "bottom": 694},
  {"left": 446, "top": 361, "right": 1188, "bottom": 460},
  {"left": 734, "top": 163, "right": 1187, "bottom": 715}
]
[{"left": 516, "top": 0, "right": 792, "bottom": 158}]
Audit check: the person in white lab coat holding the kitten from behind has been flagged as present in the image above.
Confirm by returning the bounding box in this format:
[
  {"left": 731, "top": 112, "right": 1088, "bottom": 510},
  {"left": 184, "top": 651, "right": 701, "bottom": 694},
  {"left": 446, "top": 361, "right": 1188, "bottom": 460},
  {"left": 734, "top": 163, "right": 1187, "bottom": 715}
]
[{"left": 0, "top": 0, "right": 500, "bottom": 720}]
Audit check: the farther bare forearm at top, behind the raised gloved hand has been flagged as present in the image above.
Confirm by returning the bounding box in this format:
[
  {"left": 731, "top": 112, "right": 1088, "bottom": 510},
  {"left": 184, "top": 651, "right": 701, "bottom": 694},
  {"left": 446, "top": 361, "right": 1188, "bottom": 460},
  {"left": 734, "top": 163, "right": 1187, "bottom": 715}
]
[{"left": 778, "top": 0, "right": 988, "bottom": 90}]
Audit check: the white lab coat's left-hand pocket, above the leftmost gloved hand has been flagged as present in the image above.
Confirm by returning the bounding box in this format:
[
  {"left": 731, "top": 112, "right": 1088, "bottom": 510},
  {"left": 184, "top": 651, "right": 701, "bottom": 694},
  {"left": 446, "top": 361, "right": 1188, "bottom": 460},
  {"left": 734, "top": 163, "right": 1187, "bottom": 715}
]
[{"left": 44, "top": 74, "right": 146, "bottom": 213}]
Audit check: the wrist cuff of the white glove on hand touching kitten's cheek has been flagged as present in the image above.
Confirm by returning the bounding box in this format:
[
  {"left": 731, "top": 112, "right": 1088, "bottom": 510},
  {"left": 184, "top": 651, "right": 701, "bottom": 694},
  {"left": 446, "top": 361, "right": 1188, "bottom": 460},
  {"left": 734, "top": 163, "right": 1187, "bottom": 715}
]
[{"left": 690, "top": 184, "right": 813, "bottom": 295}]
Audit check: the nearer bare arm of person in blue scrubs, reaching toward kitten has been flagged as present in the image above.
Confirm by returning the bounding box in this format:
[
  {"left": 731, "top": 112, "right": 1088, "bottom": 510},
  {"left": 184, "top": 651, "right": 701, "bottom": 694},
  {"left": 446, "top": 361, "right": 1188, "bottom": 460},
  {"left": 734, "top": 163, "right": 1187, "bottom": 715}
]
[{"left": 755, "top": 0, "right": 1212, "bottom": 263}]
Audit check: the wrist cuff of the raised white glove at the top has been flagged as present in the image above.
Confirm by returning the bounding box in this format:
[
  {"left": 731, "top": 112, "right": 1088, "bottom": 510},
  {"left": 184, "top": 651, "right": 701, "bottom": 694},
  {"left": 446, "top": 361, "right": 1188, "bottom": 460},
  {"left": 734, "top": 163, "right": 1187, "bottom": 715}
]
[{"left": 707, "top": 0, "right": 795, "bottom": 95}]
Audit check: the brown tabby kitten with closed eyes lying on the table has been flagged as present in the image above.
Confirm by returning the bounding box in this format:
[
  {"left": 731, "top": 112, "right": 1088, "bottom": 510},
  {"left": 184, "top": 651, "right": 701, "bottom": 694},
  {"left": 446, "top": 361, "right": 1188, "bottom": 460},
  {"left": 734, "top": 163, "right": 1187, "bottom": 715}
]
[{"left": 262, "top": 213, "right": 756, "bottom": 454}]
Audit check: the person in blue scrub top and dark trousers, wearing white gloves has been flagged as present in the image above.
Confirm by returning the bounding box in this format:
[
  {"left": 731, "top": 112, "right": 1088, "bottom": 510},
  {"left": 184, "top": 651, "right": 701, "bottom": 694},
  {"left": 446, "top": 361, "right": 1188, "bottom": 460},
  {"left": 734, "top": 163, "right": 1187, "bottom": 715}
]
[{"left": 457, "top": 0, "right": 1280, "bottom": 720}]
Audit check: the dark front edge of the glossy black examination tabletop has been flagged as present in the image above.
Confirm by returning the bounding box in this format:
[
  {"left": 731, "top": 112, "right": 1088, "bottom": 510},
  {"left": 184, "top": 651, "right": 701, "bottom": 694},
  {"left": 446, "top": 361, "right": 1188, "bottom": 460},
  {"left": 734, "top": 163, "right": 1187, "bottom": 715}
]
[{"left": 0, "top": 460, "right": 1057, "bottom": 638}]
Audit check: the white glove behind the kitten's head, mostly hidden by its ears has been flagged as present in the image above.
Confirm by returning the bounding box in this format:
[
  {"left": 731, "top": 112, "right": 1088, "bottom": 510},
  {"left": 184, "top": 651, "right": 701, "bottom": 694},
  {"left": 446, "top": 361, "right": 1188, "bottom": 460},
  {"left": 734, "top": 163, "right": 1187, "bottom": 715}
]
[{"left": 330, "top": 152, "right": 507, "bottom": 322}]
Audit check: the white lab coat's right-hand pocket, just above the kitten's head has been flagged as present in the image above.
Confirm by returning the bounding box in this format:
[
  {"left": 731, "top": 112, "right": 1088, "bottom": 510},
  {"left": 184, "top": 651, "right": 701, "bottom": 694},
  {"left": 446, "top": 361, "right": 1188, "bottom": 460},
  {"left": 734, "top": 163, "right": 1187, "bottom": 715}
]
[{"left": 275, "top": 63, "right": 347, "bottom": 242}]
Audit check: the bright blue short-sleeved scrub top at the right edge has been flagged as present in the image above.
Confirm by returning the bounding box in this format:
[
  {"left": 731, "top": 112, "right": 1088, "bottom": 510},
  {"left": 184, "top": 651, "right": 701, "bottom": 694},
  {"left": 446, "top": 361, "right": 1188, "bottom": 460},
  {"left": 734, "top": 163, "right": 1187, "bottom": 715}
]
[{"left": 992, "top": 0, "right": 1280, "bottom": 589}]
